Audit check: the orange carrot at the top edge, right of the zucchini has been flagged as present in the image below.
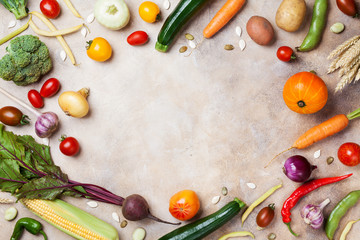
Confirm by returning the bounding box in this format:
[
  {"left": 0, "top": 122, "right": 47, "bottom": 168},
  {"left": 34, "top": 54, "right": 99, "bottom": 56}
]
[{"left": 203, "top": 0, "right": 246, "bottom": 38}]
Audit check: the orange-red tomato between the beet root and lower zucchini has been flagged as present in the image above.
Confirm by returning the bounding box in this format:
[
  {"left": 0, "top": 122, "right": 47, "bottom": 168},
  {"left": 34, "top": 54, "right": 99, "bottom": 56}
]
[{"left": 169, "top": 190, "right": 200, "bottom": 221}]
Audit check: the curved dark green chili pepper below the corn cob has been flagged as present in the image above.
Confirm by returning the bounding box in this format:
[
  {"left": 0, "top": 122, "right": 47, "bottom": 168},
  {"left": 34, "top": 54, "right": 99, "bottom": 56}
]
[{"left": 10, "top": 218, "right": 47, "bottom": 240}]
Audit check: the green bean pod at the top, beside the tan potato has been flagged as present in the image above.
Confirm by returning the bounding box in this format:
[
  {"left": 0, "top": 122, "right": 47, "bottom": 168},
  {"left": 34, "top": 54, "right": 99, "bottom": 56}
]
[{"left": 296, "top": 0, "right": 328, "bottom": 52}]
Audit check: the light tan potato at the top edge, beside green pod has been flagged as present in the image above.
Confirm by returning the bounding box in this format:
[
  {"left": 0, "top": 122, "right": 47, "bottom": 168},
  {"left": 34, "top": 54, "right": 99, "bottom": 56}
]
[{"left": 275, "top": 0, "right": 306, "bottom": 32}]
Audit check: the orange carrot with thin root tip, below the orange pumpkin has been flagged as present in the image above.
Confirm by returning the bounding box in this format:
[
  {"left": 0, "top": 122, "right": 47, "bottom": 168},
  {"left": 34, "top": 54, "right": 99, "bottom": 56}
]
[{"left": 265, "top": 108, "right": 360, "bottom": 167}]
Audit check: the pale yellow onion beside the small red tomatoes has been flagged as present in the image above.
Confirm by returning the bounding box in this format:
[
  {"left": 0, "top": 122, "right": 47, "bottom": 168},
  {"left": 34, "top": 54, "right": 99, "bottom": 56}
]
[{"left": 58, "top": 88, "right": 90, "bottom": 118}]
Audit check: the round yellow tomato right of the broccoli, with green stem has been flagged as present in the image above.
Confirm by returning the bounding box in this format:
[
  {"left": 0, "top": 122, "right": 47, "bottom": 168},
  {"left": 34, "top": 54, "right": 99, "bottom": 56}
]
[{"left": 86, "top": 37, "right": 112, "bottom": 62}]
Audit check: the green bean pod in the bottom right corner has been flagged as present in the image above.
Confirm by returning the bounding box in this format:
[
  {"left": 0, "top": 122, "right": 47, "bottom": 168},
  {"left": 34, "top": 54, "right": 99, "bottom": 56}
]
[{"left": 325, "top": 190, "right": 360, "bottom": 240}]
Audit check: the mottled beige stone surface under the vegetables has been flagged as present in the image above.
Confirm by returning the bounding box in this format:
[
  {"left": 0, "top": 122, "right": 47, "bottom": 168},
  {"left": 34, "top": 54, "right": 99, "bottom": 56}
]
[{"left": 0, "top": 0, "right": 360, "bottom": 240}]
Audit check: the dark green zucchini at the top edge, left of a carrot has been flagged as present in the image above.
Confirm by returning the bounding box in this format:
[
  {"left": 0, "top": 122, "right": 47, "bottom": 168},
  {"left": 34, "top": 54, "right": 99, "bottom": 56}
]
[{"left": 155, "top": 0, "right": 209, "bottom": 52}]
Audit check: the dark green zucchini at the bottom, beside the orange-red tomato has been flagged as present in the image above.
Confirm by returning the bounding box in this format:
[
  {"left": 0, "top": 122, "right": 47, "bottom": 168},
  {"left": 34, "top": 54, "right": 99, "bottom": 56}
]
[{"left": 159, "top": 198, "right": 246, "bottom": 240}]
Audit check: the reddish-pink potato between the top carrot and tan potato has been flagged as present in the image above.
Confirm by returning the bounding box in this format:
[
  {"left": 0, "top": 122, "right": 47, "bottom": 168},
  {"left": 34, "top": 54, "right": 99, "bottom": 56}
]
[{"left": 246, "top": 16, "right": 274, "bottom": 45}]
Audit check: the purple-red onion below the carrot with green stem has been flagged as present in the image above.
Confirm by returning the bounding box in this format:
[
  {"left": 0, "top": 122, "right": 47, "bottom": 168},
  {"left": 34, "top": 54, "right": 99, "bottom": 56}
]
[{"left": 283, "top": 155, "right": 317, "bottom": 182}]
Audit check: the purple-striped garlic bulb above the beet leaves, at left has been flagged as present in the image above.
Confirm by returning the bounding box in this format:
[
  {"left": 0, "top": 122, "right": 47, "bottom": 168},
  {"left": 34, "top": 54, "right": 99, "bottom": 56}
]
[{"left": 35, "top": 112, "right": 59, "bottom": 138}]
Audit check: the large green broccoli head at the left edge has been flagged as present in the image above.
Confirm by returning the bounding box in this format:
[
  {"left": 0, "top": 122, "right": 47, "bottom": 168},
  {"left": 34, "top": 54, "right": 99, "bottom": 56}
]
[{"left": 0, "top": 35, "right": 52, "bottom": 86}]
